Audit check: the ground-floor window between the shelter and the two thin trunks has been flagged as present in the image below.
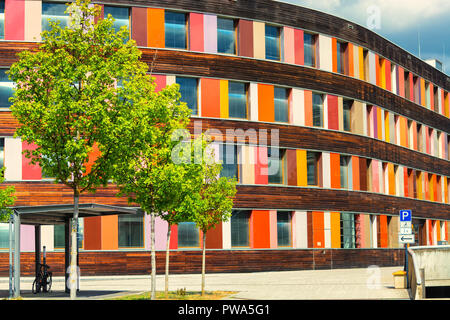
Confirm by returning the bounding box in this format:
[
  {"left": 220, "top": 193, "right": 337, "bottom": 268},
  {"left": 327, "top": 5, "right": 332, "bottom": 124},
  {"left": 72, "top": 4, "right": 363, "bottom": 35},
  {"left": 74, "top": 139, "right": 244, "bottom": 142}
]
[{"left": 119, "top": 213, "right": 144, "bottom": 248}]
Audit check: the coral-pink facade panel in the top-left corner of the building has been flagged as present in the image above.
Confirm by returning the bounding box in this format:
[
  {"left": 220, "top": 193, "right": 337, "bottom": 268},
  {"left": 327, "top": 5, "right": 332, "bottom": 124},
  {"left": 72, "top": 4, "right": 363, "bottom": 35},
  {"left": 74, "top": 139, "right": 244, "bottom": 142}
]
[{"left": 5, "top": 0, "right": 25, "bottom": 40}]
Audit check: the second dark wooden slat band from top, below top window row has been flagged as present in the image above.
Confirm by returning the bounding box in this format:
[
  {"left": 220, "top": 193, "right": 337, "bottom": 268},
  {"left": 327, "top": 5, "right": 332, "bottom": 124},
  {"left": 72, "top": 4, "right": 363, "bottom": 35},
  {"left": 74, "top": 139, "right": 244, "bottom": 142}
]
[{"left": 0, "top": 42, "right": 450, "bottom": 132}]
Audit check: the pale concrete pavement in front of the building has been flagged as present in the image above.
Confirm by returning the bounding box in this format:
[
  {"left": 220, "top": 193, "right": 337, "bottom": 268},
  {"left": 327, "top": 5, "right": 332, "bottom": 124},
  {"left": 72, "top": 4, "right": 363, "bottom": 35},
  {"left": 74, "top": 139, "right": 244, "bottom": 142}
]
[{"left": 0, "top": 267, "right": 409, "bottom": 300}]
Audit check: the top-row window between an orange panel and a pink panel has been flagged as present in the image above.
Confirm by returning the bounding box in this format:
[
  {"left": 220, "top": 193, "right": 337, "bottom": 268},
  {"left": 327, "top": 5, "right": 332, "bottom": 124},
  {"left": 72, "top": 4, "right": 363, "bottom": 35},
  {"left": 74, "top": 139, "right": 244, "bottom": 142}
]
[{"left": 164, "top": 11, "right": 187, "bottom": 49}]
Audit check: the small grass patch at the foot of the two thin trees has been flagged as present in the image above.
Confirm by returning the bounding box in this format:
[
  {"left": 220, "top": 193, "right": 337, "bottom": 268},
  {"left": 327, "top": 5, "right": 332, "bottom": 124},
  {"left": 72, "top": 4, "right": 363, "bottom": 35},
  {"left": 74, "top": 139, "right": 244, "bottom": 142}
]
[{"left": 114, "top": 290, "right": 236, "bottom": 300}]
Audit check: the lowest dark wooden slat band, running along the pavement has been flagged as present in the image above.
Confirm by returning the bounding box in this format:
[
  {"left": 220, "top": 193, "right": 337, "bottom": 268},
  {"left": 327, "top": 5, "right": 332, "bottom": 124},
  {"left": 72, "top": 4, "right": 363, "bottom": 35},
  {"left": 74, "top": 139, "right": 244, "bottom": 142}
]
[{"left": 0, "top": 249, "right": 403, "bottom": 277}]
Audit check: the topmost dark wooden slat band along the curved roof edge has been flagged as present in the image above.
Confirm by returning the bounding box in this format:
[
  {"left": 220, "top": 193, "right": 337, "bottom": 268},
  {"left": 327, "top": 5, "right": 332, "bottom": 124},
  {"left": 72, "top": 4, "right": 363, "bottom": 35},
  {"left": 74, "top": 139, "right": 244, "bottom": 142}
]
[{"left": 99, "top": 0, "right": 450, "bottom": 91}]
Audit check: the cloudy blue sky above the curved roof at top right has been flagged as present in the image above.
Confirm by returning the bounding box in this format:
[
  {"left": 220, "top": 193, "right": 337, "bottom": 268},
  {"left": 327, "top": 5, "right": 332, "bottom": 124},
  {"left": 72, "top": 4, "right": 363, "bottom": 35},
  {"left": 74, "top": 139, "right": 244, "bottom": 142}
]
[{"left": 278, "top": 0, "right": 450, "bottom": 75}]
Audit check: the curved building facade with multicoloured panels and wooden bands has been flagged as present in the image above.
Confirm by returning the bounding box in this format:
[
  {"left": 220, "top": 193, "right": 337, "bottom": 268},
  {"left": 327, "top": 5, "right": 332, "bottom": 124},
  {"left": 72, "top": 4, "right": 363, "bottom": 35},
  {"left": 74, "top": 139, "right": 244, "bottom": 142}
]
[{"left": 0, "top": 0, "right": 450, "bottom": 275}]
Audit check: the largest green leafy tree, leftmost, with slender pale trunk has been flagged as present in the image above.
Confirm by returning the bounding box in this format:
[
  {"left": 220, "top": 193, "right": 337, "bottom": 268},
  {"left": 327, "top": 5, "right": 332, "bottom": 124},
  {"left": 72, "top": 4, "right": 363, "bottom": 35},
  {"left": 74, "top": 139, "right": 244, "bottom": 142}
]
[{"left": 10, "top": 0, "right": 149, "bottom": 299}]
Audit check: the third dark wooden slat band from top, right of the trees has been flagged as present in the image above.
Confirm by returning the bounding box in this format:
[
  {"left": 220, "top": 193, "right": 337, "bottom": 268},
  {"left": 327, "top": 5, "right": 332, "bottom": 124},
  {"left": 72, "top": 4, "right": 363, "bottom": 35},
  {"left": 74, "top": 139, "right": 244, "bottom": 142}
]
[{"left": 190, "top": 118, "right": 450, "bottom": 176}]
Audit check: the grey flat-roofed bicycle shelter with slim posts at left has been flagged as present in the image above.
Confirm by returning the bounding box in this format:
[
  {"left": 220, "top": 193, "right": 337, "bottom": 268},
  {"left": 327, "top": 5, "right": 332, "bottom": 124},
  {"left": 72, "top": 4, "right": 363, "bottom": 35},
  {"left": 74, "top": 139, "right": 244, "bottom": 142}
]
[{"left": 9, "top": 203, "right": 141, "bottom": 297}]
